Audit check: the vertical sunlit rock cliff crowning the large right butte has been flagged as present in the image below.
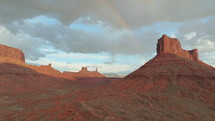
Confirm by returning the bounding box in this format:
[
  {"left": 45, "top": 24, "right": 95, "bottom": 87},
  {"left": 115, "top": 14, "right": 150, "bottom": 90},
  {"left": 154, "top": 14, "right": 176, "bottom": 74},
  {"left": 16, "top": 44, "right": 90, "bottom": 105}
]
[{"left": 157, "top": 35, "right": 199, "bottom": 61}]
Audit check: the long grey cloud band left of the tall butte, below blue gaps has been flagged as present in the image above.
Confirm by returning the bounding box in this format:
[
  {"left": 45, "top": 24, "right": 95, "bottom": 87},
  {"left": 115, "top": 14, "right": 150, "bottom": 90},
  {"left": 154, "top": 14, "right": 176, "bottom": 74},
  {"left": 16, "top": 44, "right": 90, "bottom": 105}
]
[{"left": 2, "top": 19, "right": 160, "bottom": 55}]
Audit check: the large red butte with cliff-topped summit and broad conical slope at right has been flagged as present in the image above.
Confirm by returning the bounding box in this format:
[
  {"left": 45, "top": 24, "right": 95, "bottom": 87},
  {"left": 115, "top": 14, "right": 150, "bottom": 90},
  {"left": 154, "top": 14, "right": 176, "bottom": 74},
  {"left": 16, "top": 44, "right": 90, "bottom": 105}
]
[{"left": 117, "top": 35, "right": 215, "bottom": 94}]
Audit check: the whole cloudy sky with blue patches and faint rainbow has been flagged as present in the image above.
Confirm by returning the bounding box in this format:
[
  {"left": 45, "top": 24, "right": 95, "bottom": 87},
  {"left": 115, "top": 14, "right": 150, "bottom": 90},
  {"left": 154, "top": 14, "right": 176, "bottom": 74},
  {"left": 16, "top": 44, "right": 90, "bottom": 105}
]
[{"left": 0, "top": 0, "right": 215, "bottom": 75}]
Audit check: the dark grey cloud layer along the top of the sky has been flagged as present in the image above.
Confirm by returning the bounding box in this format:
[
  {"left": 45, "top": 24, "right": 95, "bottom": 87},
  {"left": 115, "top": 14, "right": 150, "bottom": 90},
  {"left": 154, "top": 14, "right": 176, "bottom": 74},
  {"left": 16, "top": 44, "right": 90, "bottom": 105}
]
[{"left": 0, "top": 0, "right": 215, "bottom": 27}]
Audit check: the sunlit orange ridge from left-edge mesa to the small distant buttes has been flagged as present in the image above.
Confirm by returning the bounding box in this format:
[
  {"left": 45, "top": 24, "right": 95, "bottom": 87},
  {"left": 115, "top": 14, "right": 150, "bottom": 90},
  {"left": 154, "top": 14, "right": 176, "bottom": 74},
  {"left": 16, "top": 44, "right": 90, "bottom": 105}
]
[{"left": 0, "top": 45, "right": 105, "bottom": 80}]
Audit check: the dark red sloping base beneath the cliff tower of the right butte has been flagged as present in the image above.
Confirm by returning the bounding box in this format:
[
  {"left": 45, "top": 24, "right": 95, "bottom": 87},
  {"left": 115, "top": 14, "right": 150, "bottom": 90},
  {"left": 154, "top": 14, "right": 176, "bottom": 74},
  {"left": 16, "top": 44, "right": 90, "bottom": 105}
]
[{"left": 121, "top": 54, "right": 215, "bottom": 92}]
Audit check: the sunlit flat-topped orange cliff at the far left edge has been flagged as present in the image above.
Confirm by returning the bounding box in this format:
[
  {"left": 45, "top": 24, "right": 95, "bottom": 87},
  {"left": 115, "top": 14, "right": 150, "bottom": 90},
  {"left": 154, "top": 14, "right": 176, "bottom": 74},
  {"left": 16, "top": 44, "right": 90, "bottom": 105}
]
[{"left": 0, "top": 44, "right": 25, "bottom": 62}]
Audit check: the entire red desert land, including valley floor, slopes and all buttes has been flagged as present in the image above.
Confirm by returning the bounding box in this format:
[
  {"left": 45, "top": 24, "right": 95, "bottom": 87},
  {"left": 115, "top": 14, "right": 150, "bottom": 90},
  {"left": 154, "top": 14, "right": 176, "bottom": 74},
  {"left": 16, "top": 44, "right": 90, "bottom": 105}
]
[{"left": 0, "top": 35, "right": 215, "bottom": 121}]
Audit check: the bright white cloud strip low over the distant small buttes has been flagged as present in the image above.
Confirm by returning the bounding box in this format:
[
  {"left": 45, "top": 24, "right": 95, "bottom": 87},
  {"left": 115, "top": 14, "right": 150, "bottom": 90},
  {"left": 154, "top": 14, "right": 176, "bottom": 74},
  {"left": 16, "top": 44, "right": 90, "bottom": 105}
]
[{"left": 26, "top": 49, "right": 148, "bottom": 75}]
